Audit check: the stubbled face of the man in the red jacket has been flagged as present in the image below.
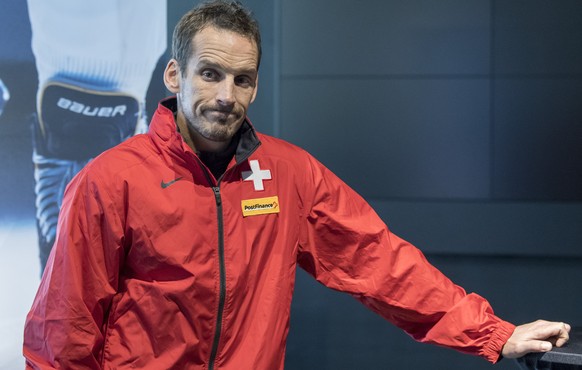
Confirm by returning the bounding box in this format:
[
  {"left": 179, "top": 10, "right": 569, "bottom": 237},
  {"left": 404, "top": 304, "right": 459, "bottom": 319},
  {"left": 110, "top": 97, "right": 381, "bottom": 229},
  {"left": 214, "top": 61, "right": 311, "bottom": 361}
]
[{"left": 166, "top": 27, "right": 258, "bottom": 150}]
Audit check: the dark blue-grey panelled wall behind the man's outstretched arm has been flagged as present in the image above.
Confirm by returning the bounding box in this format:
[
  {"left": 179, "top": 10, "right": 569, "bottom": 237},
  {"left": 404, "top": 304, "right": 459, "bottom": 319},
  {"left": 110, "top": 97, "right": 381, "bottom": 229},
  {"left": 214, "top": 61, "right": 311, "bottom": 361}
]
[{"left": 170, "top": 0, "right": 582, "bottom": 370}]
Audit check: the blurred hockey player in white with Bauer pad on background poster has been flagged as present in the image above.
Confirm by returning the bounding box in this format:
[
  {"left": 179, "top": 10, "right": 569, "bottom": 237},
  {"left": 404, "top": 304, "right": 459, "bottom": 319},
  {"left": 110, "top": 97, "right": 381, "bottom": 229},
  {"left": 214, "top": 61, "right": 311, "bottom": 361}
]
[{"left": 27, "top": 0, "right": 167, "bottom": 269}]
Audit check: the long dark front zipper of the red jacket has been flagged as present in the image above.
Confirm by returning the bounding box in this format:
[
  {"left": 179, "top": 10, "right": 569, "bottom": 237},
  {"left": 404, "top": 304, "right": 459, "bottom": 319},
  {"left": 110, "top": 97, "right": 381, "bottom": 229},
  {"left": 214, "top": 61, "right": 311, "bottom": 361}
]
[{"left": 208, "top": 186, "right": 226, "bottom": 370}]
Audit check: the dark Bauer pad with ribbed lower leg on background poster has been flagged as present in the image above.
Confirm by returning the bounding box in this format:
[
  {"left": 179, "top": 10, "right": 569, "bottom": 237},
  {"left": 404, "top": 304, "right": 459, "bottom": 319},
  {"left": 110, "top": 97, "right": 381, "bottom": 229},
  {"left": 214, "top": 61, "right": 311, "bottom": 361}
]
[{"left": 33, "top": 81, "right": 143, "bottom": 270}]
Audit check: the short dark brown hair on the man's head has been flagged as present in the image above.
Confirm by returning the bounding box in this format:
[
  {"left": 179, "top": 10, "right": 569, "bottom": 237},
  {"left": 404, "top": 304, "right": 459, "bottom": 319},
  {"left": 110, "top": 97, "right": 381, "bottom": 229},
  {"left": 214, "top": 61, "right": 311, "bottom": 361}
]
[{"left": 172, "top": 0, "right": 262, "bottom": 69}]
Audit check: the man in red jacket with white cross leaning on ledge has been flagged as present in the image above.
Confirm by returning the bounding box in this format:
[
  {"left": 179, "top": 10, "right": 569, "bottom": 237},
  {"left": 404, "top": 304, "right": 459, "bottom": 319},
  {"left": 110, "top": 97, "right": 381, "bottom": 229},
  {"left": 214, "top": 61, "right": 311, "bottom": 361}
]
[{"left": 24, "top": 1, "right": 570, "bottom": 370}]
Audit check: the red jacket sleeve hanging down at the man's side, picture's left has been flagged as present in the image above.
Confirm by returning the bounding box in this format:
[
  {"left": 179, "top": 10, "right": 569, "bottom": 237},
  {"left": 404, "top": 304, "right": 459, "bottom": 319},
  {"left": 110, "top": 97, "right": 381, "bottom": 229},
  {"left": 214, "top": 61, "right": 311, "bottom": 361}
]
[{"left": 23, "top": 171, "right": 124, "bottom": 369}]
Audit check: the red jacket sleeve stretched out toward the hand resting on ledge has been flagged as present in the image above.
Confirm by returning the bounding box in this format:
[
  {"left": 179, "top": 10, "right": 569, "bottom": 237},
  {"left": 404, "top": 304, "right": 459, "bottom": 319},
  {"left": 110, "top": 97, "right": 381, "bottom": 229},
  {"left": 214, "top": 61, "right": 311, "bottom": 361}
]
[{"left": 299, "top": 155, "right": 515, "bottom": 363}]
